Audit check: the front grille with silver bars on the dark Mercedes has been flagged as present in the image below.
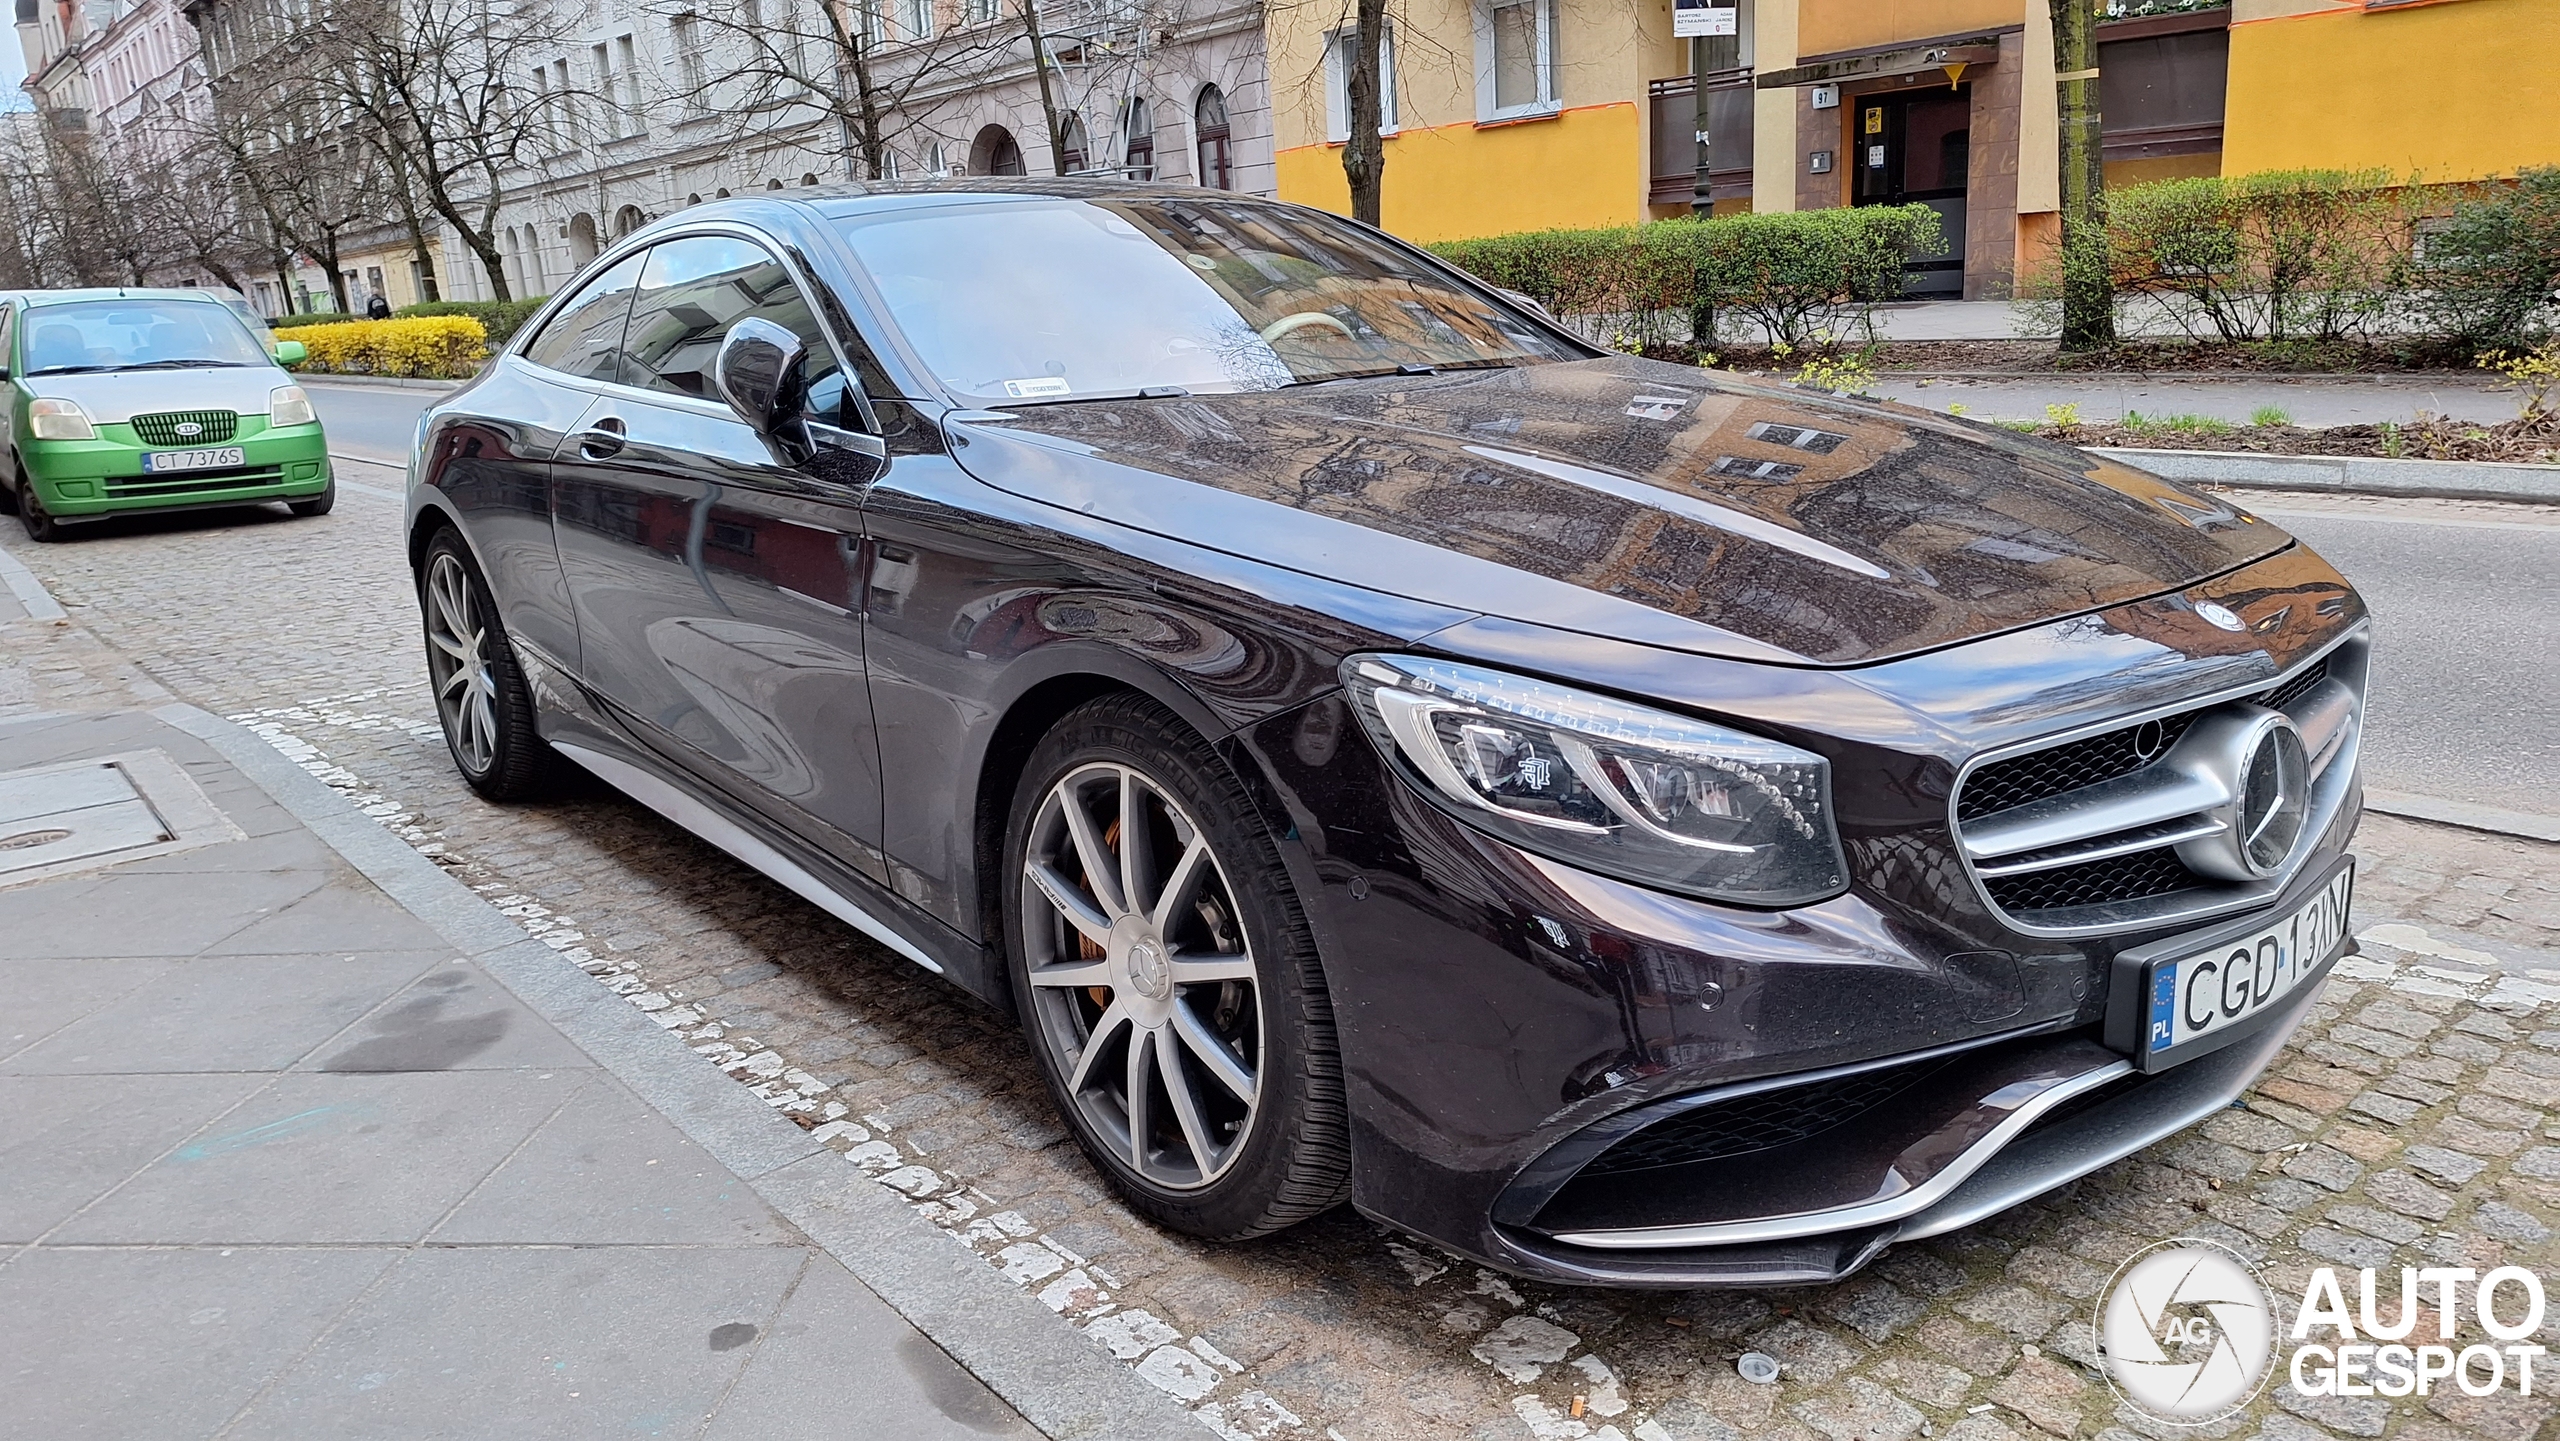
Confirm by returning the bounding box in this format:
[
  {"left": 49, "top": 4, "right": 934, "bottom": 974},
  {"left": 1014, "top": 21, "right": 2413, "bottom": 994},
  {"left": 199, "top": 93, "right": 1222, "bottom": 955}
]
[{"left": 1953, "top": 640, "right": 2363, "bottom": 934}]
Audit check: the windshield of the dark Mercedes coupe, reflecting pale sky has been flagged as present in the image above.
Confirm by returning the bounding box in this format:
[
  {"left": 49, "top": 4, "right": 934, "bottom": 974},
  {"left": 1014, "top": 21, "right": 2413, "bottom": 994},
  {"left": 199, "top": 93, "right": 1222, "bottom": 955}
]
[{"left": 845, "top": 200, "right": 1580, "bottom": 404}]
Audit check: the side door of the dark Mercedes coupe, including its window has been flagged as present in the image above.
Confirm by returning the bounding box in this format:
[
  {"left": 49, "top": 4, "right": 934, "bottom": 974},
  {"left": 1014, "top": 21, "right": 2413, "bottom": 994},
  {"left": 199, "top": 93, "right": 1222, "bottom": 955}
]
[{"left": 553, "top": 235, "right": 886, "bottom": 878}]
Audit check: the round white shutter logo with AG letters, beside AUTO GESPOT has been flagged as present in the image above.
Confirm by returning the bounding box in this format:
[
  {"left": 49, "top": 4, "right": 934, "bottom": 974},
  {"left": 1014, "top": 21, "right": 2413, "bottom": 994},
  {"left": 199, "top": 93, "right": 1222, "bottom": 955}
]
[{"left": 2097, "top": 1241, "right": 2276, "bottom": 1426}]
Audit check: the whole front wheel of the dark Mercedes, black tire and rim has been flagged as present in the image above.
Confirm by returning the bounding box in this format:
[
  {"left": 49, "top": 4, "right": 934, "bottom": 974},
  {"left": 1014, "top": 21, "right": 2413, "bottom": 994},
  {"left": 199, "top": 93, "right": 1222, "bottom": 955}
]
[{"left": 996, "top": 696, "right": 1352, "bottom": 1241}]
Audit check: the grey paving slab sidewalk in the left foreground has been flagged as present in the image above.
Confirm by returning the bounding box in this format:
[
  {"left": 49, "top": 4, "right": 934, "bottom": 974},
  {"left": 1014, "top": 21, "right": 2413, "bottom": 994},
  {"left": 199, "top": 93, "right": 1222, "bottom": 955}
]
[{"left": 0, "top": 696, "right": 1141, "bottom": 1441}]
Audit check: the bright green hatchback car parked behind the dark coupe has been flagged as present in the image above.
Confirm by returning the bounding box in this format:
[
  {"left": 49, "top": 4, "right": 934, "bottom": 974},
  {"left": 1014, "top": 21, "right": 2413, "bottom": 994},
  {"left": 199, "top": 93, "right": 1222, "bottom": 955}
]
[{"left": 0, "top": 289, "right": 338, "bottom": 540}]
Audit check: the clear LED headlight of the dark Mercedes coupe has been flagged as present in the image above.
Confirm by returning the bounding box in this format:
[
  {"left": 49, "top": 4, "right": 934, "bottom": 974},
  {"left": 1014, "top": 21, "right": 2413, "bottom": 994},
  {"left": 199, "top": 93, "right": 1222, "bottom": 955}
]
[{"left": 1341, "top": 655, "right": 1848, "bottom": 906}]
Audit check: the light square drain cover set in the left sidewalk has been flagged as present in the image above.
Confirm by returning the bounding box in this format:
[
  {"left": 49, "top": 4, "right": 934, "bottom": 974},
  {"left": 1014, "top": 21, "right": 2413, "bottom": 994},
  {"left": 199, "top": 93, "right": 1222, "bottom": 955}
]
[{"left": 0, "top": 750, "right": 241, "bottom": 886}]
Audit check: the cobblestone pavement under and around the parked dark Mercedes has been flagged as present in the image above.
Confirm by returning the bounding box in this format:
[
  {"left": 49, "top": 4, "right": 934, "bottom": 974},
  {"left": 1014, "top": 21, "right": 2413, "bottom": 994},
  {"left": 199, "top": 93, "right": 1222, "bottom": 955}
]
[{"left": 0, "top": 471, "right": 2560, "bottom": 1441}]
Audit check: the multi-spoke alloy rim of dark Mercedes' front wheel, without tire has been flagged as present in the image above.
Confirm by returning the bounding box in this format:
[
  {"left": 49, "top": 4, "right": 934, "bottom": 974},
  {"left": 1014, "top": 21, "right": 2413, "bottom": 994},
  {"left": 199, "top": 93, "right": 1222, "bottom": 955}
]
[{"left": 1021, "top": 763, "right": 1265, "bottom": 1190}]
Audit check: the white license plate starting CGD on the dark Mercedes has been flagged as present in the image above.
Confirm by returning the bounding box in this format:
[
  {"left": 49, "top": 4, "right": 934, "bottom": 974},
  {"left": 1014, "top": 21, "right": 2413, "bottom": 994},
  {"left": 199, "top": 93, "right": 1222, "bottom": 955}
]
[{"left": 2143, "top": 863, "right": 2355, "bottom": 1070}]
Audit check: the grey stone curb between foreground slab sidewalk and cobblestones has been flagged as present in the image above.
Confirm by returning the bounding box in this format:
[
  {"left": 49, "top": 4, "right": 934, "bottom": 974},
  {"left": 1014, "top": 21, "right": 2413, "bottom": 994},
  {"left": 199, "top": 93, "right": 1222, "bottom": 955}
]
[{"left": 151, "top": 704, "right": 1203, "bottom": 1441}]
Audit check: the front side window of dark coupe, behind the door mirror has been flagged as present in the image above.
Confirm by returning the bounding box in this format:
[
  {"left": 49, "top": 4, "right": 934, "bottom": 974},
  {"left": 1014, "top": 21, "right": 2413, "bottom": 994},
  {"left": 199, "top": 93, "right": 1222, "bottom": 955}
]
[{"left": 627, "top": 235, "right": 842, "bottom": 399}]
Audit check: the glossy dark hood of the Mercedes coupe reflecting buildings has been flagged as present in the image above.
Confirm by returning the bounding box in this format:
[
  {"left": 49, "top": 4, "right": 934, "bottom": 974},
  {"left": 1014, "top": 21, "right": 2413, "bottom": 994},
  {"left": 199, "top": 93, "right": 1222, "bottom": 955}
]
[{"left": 960, "top": 356, "right": 2291, "bottom": 665}]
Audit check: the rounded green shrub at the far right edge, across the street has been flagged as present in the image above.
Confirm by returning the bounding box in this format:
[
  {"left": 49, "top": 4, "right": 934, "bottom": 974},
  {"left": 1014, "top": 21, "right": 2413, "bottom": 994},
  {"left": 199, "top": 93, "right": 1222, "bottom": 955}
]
[{"left": 2417, "top": 169, "right": 2560, "bottom": 351}]
